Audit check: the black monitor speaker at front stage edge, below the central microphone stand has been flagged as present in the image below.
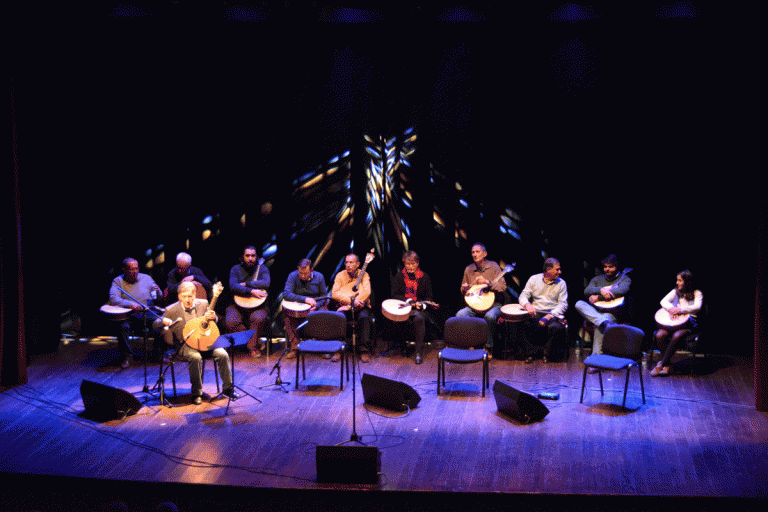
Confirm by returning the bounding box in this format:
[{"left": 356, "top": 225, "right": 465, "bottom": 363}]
[{"left": 315, "top": 446, "right": 381, "bottom": 484}]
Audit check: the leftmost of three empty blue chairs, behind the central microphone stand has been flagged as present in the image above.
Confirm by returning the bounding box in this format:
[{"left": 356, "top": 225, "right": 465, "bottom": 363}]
[{"left": 294, "top": 311, "right": 349, "bottom": 390}]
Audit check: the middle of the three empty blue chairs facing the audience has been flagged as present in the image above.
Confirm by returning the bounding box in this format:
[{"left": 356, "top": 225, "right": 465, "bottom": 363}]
[{"left": 437, "top": 316, "right": 491, "bottom": 397}]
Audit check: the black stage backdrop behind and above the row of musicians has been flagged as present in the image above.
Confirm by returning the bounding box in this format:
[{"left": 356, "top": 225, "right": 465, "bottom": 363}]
[{"left": 9, "top": 3, "right": 762, "bottom": 360}]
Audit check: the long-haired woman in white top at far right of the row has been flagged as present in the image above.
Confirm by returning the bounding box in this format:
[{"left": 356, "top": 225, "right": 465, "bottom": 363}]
[{"left": 651, "top": 270, "right": 704, "bottom": 377}]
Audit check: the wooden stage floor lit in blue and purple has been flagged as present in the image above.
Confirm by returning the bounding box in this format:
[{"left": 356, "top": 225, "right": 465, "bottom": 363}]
[{"left": 0, "top": 341, "right": 768, "bottom": 510}]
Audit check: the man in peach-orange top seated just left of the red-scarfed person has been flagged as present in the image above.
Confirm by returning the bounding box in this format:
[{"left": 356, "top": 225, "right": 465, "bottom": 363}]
[{"left": 331, "top": 254, "right": 373, "bottom": 363}]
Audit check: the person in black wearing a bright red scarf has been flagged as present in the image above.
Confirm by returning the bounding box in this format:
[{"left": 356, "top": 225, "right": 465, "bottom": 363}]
[{"left": 392, "top": 251, "right": 432, "bottom": 364}]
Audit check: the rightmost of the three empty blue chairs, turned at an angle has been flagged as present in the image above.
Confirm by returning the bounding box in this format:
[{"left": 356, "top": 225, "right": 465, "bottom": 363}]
[{"left": 579, "top": 324, "right": 645, "bottom": 407}]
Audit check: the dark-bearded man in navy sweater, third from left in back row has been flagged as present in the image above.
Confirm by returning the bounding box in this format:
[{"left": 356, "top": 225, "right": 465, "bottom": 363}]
[{"left": 224, "top": 245, "right": 270, "bottom": 359}]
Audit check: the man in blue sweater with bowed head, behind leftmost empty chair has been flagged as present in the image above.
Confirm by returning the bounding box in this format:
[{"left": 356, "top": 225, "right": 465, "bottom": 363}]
[{"left": 283, "top": 258, "right": 328, "bottom": 359}]
